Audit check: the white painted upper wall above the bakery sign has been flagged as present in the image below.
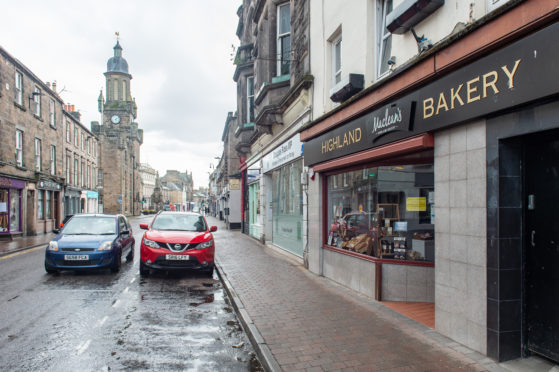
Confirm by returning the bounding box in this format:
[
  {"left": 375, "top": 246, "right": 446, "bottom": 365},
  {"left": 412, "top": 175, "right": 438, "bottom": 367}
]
[{"left": 310, "top": 0, "right": 494, "bottom": 119}]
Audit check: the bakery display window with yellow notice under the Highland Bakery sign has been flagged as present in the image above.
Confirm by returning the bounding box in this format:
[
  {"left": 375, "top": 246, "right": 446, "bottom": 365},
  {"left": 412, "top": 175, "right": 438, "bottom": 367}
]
[{"left": 327, "top": 164, "right": 435, "bottom": 262}]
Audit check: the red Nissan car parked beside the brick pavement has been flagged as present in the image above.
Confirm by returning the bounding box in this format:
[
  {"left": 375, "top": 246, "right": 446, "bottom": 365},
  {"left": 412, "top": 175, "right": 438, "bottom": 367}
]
[{"left": 140, "top": 212, "right": 217, "bottom": 277}]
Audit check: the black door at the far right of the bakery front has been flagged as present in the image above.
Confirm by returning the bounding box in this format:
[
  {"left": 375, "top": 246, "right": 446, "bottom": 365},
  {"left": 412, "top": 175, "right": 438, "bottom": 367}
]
[{"left": 525, "top": 131, "right": 559, "bottom": 361}]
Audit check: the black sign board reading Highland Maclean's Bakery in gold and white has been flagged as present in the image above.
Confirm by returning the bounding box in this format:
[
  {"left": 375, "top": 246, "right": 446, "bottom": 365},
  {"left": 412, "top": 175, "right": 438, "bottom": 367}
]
[{"left": 305, "top": 23, "right": 559, "bottom": 165}]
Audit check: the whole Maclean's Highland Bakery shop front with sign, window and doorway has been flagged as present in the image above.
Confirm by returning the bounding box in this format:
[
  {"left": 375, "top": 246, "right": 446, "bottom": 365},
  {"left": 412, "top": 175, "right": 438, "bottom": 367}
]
[{"left": 300, "top": 18, "right": 559, "bottom": 361}]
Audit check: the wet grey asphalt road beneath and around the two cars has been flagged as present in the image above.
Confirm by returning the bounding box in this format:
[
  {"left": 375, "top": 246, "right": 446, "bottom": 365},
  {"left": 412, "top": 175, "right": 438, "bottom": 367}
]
[{"left": 0, "top": 217, "right": 259, "bottom": 371}]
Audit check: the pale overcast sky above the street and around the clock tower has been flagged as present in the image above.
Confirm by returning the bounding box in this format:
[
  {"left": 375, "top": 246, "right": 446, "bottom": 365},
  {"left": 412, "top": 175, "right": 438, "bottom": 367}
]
[{"left": 0, "top": 0, "right": 241, "bottom": 187}]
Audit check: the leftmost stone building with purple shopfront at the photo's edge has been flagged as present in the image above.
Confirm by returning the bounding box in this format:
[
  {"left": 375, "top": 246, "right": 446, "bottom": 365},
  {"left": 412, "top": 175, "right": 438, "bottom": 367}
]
[{"left": 0, "top": 47, "right": 64, "bottom": 238}]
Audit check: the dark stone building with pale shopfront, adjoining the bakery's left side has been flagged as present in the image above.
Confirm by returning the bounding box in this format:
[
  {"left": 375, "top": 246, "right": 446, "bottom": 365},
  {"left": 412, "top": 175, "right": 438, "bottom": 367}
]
[{"left": 233, "top": 0, "right": 313, "bottom": 250}]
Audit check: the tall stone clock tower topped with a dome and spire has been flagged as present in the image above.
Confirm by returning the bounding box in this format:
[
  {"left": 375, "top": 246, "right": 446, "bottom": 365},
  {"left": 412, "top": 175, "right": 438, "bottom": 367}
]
[{"left": 91, "top": 41, "right": 144, "bottom": 215}]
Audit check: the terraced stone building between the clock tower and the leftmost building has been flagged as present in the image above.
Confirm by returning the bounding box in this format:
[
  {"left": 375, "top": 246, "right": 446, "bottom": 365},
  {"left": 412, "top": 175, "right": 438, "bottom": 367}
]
[{"left": 62, "top": 105, "right": 99, "bottom": 215}]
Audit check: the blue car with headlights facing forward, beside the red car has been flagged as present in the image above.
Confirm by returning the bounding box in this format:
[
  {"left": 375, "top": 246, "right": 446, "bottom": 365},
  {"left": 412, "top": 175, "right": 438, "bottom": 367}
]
[{"left": 45, "top": 214, "right": 135, "bottom": 274}]
